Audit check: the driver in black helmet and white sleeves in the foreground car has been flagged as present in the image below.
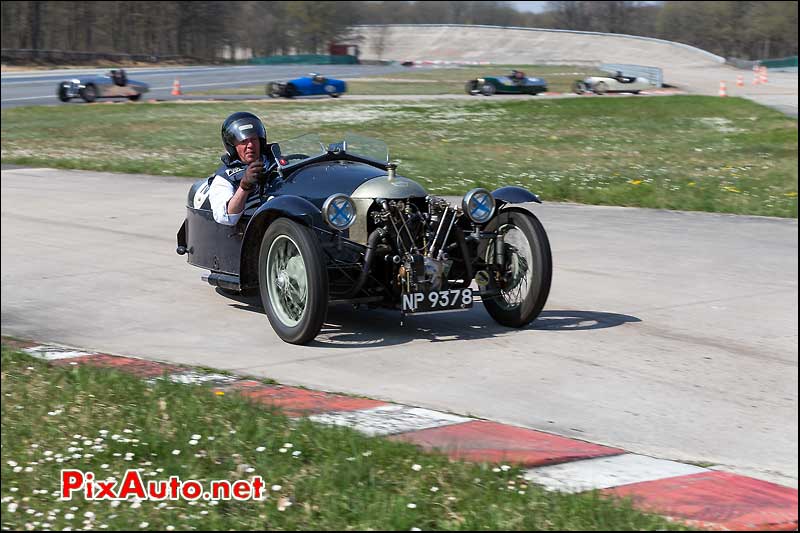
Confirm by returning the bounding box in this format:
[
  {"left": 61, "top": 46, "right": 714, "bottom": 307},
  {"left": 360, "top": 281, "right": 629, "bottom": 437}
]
[{"left": 208, "top": 111, "right": 268, "bottom": 226}]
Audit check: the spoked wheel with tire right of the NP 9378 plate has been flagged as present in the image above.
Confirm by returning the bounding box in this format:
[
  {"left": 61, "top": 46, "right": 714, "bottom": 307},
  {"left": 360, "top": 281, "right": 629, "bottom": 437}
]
[{"left": 481, "top": 211, "right": 553, "bottom": 328}]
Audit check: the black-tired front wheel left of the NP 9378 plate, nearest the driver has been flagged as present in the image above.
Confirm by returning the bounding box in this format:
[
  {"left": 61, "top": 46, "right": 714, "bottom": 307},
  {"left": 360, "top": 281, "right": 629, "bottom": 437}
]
[{"left": 258, "top": 218, "right": 328, "bottom": 344}]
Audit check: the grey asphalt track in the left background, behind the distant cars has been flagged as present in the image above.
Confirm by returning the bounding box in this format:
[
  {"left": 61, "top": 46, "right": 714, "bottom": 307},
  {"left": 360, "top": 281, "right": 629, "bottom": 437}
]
[{"left": 0, "top": 65, "right": 406, "bottom": 108}]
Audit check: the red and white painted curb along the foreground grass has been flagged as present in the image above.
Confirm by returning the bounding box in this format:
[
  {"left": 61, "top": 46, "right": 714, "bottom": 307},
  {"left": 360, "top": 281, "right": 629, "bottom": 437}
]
[{"left": 9, "top": 340, "right": 798, "bottom": 531}]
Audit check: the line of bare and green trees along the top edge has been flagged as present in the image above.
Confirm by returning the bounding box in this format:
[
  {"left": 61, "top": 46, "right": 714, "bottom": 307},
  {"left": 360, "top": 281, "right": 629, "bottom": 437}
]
[{"left": 0, "top": 1, "right": 797, "bottom": 61}]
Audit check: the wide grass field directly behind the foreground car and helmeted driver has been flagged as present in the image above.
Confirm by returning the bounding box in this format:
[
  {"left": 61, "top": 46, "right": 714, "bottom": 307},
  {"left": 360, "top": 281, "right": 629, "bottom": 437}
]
[{"left": 1, "top": 96, "right": 798, "bottom": 218}]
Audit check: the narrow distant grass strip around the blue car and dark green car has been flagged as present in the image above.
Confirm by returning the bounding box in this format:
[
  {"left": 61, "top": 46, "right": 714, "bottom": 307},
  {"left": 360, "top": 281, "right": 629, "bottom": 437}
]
[{"left": 188, "top": 65, "right": 601, "bottom": 98}]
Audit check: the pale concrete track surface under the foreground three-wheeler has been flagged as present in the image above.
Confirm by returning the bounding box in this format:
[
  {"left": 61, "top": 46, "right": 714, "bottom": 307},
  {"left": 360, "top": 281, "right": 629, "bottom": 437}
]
[{"left": 0, "top": 165, "right": 798, "bottom": 487}]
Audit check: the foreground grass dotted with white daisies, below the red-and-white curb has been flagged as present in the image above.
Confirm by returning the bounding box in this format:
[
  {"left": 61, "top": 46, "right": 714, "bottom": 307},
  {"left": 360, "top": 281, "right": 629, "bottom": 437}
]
[{"left": 0, "top": 345, "right": 682, "bottom": 531}]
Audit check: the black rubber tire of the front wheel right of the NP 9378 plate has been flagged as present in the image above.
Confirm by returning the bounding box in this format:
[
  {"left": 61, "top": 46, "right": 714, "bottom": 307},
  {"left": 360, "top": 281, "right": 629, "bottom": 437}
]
[{"left": 479, "top": 210, "right": 553, "bottom": 328}]
